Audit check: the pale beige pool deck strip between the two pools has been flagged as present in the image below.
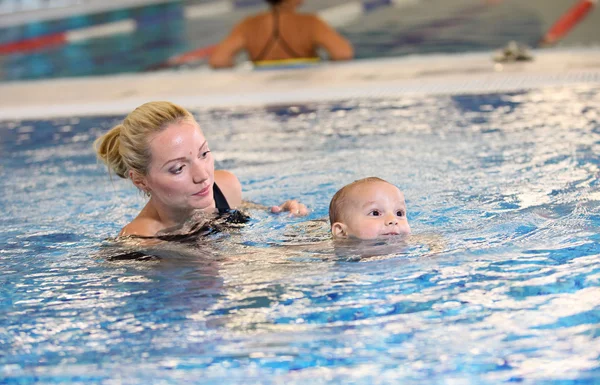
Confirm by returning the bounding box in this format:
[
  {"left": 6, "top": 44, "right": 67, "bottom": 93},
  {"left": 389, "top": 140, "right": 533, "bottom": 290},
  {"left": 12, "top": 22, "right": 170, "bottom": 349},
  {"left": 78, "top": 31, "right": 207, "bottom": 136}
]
[{"left": 0, "top": 48, "right": 600, "bottom": 120}]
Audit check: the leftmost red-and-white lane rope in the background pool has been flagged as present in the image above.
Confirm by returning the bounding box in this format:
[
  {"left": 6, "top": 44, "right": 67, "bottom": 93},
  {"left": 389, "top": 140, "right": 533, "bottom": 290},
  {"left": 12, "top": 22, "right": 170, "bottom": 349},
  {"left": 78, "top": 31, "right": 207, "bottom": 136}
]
[{"left": 0, "top": 19, "right": 137, "bottom": 55}]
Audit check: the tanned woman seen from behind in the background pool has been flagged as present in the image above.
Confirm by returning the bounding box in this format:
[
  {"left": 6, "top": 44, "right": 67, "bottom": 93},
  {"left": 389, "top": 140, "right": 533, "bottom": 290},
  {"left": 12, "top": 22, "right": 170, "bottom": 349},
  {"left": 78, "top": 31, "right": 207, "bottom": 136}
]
[{"left": 210, "top": 0, "right": 354, "bottom": 68}]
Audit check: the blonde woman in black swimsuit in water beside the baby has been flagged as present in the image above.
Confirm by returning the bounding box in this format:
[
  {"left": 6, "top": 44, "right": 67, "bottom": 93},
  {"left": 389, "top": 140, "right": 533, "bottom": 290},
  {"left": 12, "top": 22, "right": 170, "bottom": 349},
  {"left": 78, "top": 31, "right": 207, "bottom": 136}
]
[{"left": 95, "top": 102, "right": 308, "bottom": 237}]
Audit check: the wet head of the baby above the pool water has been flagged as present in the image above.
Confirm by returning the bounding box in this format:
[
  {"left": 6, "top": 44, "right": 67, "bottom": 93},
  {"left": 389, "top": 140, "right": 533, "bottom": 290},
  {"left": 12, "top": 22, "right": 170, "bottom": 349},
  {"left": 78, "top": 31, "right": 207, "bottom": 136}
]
[{"left": 329, "top": 177, "right": 410, "bottom": 239}]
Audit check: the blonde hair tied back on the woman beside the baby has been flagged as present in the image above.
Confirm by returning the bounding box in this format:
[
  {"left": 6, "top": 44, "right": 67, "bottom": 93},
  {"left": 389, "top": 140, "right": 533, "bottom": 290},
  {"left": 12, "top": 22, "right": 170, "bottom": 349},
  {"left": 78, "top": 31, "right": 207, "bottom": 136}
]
[{"left": 94, "top": 102, "right": 195, "bottom": 178}]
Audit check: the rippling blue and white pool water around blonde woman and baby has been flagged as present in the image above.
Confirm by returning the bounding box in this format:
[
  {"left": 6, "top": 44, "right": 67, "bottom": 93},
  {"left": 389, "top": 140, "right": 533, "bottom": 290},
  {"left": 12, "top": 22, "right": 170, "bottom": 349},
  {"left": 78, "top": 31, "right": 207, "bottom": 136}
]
[{"left": 0, "top": 86, "right": 600, "bottom": 384}]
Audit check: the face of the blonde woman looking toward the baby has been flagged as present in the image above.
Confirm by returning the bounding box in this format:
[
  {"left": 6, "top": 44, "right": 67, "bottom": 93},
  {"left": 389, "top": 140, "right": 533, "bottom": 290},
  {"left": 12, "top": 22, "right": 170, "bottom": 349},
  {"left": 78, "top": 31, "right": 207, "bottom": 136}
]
[{"left": 145, "top": 121, "right": 215, "bottom": 211}]
